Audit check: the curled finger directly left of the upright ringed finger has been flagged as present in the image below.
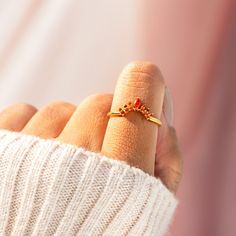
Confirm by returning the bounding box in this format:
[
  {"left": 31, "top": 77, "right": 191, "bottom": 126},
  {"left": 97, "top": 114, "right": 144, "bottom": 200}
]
[{"left": 58, "top": 94, "right": 113, "bottom": 151}]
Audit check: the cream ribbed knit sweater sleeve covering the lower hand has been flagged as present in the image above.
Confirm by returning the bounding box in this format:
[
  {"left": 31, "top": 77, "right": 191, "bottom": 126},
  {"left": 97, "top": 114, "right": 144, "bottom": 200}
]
[{"left": 0, "top": 130, "right": 177, "bottom": 236}]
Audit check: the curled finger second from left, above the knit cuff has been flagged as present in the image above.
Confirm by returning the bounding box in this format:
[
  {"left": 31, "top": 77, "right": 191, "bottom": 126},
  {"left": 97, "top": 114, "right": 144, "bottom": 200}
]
[{"left": 22, "top": 102, "right": 76, "bottom": 138}]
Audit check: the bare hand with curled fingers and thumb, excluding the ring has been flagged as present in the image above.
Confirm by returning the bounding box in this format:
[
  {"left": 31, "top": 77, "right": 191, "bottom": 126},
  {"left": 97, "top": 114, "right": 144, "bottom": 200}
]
[{"left": 0, "top": 61, "right": 182, "bottom": 193}]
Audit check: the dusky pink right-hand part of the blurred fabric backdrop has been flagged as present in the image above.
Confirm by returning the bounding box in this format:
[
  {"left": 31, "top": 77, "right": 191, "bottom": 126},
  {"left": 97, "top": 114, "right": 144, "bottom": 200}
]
[{"left": 143, "top": 0, "right": 236, "bottom": 236}]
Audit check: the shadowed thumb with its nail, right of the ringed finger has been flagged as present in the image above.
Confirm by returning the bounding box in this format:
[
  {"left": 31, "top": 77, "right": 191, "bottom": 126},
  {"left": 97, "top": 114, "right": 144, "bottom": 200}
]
[{"left": 155, "top": 89, "right": 183, "bottom": 193}]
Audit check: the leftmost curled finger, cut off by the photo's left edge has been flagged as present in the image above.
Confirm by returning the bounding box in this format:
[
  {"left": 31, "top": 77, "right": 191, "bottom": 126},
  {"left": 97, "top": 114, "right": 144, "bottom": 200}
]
[{"left": 0, "top": 103, "right": 37, "bottom": 132}]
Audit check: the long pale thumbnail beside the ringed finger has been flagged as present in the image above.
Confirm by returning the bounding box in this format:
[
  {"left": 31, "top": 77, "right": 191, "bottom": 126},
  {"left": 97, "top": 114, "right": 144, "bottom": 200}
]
[{"left": 163, "top": 87, "right": 174, "bottom": 126}]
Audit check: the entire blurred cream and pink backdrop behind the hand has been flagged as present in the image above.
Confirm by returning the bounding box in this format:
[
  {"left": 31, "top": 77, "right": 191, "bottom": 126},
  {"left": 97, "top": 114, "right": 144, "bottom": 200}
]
[{"left": 0, "top": 0, "right": 236, "bottom": 236}]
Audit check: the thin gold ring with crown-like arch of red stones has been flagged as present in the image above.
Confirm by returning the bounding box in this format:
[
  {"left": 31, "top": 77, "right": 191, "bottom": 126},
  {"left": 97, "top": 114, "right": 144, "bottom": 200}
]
[{"left": 107, "top": 98, "right": 162, "bottom": 126}]
